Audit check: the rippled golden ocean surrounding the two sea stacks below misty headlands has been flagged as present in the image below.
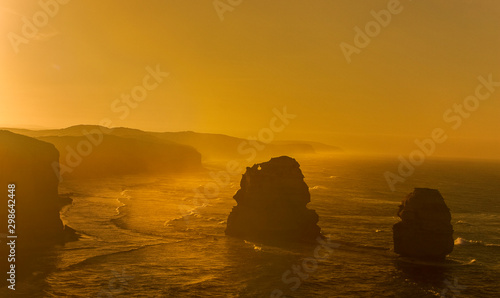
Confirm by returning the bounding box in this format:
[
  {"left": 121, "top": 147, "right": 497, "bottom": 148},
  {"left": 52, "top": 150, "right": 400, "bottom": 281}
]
[{"left": 5, "top": 155, "right": 500, "bottom": 297}]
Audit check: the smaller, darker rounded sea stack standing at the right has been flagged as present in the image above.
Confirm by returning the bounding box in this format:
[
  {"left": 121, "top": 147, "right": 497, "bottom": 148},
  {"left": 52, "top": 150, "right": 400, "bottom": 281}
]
[{"left": 393, "top": 188, "right": 454, "bottom": 259}]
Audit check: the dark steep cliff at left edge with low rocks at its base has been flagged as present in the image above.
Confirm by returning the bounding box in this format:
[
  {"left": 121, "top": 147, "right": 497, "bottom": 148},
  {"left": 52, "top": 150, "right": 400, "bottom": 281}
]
[{"left": 0, "top": 131, "right": 77, "bottom": 285}]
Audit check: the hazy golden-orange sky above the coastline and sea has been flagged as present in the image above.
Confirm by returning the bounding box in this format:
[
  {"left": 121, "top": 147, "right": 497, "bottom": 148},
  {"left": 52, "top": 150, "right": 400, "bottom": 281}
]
[{"left": 0, "top": 0, "right": 500, "bottom": 155}]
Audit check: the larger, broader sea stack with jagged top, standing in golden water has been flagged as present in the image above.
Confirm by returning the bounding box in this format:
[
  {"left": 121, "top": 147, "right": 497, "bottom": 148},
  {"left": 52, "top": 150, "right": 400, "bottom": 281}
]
[{"left": 226, "top": 156, "right": 321, "bottom": 243}]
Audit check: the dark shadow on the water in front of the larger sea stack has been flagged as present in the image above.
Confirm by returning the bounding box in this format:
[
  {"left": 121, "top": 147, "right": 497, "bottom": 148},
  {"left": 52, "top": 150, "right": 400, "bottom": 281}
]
[{"left": 224, "top": 237, "right": 348, "bottom": 297}]
